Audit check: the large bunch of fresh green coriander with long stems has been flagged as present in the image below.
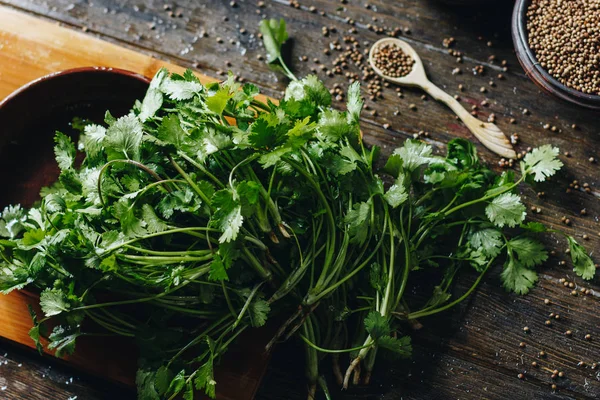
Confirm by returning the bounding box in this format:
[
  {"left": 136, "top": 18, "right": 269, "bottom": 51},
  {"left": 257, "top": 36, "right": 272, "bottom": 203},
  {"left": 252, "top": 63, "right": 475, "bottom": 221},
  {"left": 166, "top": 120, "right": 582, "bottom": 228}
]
[{"left": 0, "top": 21, "right": 595, "bottom": 400}]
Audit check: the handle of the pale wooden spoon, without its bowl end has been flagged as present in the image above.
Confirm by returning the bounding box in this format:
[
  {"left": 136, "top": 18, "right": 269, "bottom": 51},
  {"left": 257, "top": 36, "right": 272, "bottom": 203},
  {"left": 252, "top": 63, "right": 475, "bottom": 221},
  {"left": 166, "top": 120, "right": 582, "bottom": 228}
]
[{"left": 422, "top": 81, "right": 517, "bottom": 158}]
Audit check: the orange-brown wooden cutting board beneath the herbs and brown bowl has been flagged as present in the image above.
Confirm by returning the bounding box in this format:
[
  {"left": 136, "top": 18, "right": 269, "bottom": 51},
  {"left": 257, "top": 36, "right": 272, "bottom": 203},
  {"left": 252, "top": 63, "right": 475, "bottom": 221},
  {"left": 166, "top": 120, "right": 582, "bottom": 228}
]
[{"left": 0, "top": 7, "right": 269, "bottom": 400}]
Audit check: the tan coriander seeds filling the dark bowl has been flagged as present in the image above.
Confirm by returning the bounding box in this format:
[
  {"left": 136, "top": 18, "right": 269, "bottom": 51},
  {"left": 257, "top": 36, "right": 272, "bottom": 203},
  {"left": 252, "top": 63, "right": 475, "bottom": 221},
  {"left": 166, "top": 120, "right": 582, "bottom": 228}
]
[{"left": 526, "top": 0, "right": 600, "bottom": 95}]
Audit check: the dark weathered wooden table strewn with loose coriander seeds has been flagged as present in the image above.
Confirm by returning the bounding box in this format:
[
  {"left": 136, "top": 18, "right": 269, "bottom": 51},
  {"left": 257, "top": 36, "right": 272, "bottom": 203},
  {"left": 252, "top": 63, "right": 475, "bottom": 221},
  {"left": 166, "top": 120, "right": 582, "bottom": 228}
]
[{"left": 0, "top": 0, "right": 600, "bottom": 400}]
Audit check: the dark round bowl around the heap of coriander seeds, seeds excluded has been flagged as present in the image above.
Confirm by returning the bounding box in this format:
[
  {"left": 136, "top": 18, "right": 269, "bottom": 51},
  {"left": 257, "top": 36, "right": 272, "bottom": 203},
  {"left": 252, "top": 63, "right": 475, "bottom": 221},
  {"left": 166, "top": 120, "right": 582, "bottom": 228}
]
[{"left": 512, "top": 0, "right": 600, "bottom": 110}]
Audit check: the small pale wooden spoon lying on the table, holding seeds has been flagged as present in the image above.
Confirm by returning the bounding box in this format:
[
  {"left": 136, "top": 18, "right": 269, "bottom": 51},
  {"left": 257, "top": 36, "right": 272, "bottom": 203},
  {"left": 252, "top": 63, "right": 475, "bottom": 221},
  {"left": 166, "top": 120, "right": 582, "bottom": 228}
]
[{"left": 369, "top": 38, "right": 517, "bottom": 158}]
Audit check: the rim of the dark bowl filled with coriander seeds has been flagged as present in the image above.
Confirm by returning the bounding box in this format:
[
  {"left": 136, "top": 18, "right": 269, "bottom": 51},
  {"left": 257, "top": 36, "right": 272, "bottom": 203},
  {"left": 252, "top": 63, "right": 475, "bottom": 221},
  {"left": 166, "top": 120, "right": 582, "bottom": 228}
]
[{"left": 513, "top": 0, "right": 600, "bottom": 106}]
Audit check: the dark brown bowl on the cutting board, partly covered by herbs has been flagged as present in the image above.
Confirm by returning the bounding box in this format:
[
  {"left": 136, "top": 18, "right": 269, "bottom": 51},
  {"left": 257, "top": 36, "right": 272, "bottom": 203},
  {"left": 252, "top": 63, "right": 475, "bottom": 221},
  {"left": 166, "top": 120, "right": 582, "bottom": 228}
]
[{"left": 0, "top": 67, "right": 150, "bottom": 207}]
